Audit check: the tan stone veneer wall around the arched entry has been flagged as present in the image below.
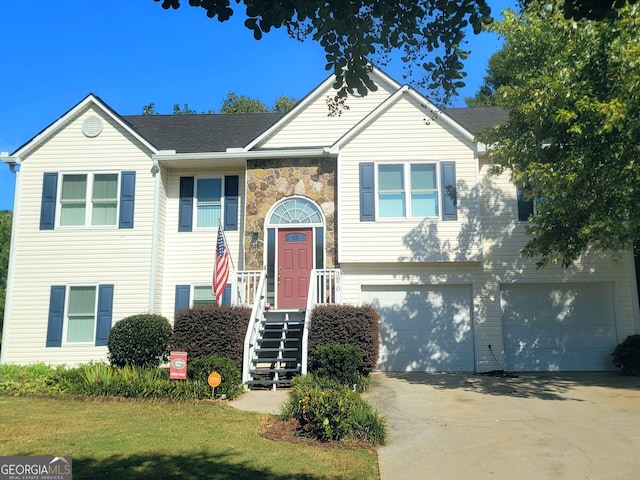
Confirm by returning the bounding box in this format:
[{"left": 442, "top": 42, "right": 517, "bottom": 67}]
[{"left": 244, "top": 158, "right": 336, "bottom": 270}]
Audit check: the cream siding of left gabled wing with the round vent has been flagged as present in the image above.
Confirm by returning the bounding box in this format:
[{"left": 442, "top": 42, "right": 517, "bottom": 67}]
[{"left": 3, "top": 110, "right": 154, "bottom": 364}]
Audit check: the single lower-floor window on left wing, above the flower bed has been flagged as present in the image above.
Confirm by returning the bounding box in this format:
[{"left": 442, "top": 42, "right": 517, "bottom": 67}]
[{"left": 62, "top": 285, "right": 98, "bottom": 344}]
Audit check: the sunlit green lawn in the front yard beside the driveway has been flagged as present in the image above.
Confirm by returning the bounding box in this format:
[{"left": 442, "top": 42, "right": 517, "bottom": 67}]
[{"left": 0, "top": 396, "right": 379, "bottom": 480}]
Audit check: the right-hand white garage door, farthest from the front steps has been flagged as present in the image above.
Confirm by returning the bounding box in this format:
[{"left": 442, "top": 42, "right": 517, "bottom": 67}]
[{"left": 501, "top": 283, "right": 618, "bottom": 371}]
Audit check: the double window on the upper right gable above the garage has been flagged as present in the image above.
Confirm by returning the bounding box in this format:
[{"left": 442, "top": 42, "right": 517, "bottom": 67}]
[{"left": 376, "top": 162, "right": 439, "bottom": 218}]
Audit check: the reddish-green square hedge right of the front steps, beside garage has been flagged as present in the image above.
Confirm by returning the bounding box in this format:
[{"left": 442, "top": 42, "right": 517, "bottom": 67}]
[{"left": 309, "top": 305, "right": 380, "bottom": 375}]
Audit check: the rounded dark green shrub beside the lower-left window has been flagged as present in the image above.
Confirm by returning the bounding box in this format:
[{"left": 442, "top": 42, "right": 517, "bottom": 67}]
[{"left": 107, "top": 313, "right": 171, "bottom": 367}]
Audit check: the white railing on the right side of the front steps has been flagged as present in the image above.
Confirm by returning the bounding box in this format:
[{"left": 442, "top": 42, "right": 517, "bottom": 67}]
[{"left": 300, "top": 268, "right": 342, "bottom": 375}]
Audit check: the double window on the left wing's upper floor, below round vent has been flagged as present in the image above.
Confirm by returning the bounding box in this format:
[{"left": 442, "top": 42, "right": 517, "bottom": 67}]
[{"left": 59, "top": 172, "right": 119, "bottom": 227}]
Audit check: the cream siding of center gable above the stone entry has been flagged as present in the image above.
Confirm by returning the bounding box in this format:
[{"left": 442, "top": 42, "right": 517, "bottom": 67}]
[{"left": 259, "top": 77, "right": 396, "bottom": 148}]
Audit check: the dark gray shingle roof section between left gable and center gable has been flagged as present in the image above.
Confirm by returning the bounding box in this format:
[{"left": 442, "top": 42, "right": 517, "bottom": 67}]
[{"left": 122, "top": 113, "right": 283, "bottom": 153}]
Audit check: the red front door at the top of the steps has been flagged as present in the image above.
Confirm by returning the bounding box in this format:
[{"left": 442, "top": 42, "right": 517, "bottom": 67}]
[{"left": 277, "top": 228, "right": 313, "bottom": 308}]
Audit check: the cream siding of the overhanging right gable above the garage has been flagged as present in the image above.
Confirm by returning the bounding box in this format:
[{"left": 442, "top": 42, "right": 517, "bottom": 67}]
[{"left": 338, "top": 95, "right": 482, "bottom": 263}]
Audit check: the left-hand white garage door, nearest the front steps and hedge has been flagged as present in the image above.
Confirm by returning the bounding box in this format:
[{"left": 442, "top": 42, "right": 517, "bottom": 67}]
[{"left": 362, "top": 285, "right": 474, "bottom": 372}]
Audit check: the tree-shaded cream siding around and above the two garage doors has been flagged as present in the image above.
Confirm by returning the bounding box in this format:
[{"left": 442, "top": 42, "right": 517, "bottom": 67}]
[{"left": 341, "top": 158, "right": 638, "bottom": 371}]
